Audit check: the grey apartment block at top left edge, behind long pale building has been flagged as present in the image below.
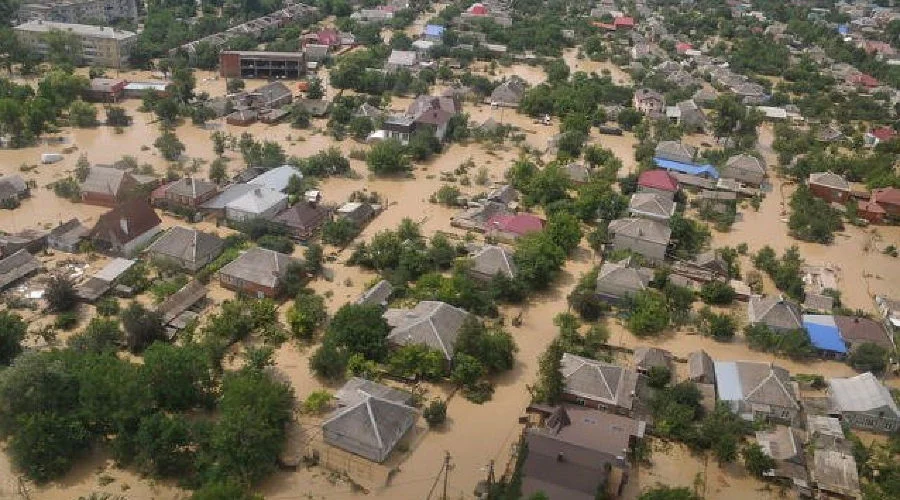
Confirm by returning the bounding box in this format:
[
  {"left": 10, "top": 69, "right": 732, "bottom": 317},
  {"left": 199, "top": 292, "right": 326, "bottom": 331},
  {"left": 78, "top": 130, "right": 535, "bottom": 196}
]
[{"left": 19, "top": 0, "right": 138, "bottom": 23}]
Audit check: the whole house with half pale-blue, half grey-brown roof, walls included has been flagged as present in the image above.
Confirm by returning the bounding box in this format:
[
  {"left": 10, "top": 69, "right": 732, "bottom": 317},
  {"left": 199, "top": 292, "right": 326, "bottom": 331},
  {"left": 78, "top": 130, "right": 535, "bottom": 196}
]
[{"left": 713, "top": 361, "right": 800, "bottom": 423}]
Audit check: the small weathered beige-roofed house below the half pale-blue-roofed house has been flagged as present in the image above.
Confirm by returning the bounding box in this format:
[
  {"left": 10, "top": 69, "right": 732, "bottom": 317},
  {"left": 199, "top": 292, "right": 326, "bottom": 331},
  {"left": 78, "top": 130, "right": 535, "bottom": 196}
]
[{"left": 756, "top": 425, "right": 809, "bottom": 492}]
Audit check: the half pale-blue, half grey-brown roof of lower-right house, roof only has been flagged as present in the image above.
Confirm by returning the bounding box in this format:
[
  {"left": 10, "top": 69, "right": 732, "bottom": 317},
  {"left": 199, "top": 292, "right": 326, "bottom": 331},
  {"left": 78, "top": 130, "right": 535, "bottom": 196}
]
[{"left": 713, "top": 361, "right": 800, "bottom": 409}]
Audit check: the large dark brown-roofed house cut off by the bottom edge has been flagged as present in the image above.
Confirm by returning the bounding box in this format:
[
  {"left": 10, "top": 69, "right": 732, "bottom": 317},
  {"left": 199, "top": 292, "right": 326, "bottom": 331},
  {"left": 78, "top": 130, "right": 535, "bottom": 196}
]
[{"left": 521, "top": 405, "right": 646, "bottom": 500}]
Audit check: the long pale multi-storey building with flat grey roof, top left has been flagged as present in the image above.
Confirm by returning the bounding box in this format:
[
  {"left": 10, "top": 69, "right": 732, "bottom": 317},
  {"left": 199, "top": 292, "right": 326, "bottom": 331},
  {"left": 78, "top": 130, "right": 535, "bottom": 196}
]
[{"left": 15, "top": 21, "right": 137, "bottom": 67}]
